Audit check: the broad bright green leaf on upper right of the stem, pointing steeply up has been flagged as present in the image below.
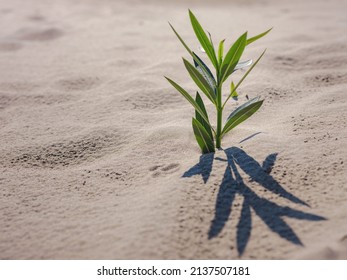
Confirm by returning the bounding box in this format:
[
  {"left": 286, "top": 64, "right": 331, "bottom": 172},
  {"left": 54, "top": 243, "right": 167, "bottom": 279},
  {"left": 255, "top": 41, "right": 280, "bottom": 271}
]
[{"left": 221, "top": 32, "right": 247, "bottom": 82}]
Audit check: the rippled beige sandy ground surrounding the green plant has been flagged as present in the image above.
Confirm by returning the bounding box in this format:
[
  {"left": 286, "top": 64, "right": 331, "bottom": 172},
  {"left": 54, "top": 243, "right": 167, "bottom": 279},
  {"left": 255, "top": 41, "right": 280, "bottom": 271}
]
[{"left": 0, "top": 0, "right": 347, "bottom": 259}]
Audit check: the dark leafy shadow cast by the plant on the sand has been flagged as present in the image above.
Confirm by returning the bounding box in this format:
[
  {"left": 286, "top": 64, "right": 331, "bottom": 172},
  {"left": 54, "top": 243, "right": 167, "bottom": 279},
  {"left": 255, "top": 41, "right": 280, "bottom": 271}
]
[{"left": 182, "top": 147, "right": 326, "bottom": 256}]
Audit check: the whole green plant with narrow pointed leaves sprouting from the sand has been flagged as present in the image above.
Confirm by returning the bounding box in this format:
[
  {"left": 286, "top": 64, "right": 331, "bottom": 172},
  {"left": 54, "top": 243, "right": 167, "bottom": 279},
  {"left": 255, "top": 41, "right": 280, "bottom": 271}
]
[{"left": 165, "top": 10, "right": 271, "bottom": 153}]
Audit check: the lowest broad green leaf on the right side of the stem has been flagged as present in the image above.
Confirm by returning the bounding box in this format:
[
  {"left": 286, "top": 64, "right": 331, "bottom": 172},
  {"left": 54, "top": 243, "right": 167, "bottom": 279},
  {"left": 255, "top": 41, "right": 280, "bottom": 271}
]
[{"left": 221, "top": 97, "right": 264, "bottom": 137}]
